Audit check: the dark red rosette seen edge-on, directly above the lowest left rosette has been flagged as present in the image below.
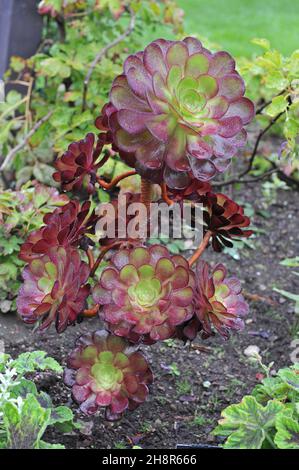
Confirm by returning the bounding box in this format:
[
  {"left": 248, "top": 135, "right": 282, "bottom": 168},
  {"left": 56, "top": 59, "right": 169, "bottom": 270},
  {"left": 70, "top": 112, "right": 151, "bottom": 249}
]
[{"left": 19, "top": 200, "right": 97, "bottom": 262}]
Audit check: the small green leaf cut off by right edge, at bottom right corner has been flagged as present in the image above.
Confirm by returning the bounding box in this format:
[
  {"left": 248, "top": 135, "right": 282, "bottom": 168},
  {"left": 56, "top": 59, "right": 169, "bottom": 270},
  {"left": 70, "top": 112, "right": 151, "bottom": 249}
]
[{"left": 274, "top": 414, "right": 299, "bottom": 449}]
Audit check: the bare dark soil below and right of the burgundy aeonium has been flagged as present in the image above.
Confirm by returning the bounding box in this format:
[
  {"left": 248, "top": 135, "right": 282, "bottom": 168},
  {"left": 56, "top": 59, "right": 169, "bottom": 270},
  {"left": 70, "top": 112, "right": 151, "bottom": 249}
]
[{"left": 0, "top": 183, "right": 299, "bottom": 449}]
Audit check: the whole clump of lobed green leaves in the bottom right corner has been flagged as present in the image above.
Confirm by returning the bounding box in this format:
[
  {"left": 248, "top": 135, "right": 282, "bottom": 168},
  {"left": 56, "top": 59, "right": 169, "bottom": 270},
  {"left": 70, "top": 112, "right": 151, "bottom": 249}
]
[{"left": 214, "top": 364, "right": 299, "bottom": 449}]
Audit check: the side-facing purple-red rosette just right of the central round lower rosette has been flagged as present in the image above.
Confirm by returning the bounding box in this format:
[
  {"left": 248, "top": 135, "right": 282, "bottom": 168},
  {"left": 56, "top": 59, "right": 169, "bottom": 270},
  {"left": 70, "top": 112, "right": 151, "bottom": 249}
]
[{"left": 190, "top": 260, "right": 249, "bottom": 339}]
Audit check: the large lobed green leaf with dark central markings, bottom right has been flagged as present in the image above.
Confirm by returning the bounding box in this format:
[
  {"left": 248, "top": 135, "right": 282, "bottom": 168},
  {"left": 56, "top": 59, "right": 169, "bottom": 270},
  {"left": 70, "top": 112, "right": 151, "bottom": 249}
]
[{"left": 213, "top": 395, "right": 284, "bottom": 449}]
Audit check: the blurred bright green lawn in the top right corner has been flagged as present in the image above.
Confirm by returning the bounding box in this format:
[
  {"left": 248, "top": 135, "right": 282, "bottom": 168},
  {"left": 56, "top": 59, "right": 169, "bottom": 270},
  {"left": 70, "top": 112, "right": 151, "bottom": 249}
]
[{"left": 177, "top": 0, "right": 299, "bottom": 56}]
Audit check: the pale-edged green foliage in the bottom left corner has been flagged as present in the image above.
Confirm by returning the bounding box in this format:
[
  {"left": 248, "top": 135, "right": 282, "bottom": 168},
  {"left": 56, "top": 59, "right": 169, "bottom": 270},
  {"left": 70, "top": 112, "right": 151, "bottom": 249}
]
[{"left": 0, "top": 351, "right": 75, "bottom": 449}]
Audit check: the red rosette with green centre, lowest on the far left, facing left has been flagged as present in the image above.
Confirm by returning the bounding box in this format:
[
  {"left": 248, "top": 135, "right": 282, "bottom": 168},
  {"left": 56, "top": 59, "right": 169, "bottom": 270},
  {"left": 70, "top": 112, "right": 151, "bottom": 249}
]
[{"left": 17, "top": 247, "right": 90, "bottom": 333}]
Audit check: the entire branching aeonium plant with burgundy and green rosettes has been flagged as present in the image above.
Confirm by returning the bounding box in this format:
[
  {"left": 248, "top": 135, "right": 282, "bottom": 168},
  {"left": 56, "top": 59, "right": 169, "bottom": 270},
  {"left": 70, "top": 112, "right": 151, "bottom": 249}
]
[{"left": 18, "top": 37, "right": 254, "bottom": 420}]
